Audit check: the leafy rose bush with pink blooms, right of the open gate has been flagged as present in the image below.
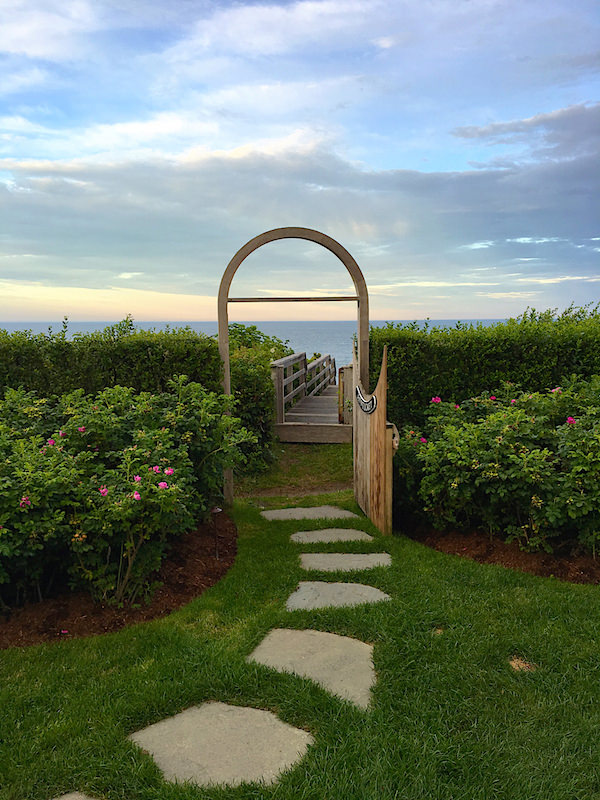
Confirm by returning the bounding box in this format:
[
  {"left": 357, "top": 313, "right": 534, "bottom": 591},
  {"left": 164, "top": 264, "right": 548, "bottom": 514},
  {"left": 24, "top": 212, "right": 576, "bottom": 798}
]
[{"left": 395, "top": 376, "right": 600, "bottom": 553}]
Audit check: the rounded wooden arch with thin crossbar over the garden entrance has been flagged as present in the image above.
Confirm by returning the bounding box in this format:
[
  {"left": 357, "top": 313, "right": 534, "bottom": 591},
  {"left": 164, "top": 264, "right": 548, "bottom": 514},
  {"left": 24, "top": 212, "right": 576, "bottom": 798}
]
[{"left": 217, "top": 228, "right": 369, "bottom": 394}]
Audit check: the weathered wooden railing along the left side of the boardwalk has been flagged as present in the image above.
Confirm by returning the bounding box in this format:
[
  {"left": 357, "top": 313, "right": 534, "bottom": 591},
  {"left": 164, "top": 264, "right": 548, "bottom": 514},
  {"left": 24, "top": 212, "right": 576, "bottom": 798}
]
[{"left": 271, "top": 353, "right": 336, "bottom": 423}]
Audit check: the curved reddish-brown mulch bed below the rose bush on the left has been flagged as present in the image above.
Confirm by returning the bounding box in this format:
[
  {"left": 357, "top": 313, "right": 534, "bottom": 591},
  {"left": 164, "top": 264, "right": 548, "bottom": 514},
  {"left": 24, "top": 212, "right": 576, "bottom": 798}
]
[{"left": 0, "top": 513, "right": 237, "bottom": 649}]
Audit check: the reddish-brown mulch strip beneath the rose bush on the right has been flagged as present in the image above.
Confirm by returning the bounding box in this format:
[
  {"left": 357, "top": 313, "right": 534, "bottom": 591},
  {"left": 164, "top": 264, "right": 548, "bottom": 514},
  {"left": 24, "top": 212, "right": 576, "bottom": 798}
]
[{"left": 408, "top": 529, "right": 600, "bottom": 584}]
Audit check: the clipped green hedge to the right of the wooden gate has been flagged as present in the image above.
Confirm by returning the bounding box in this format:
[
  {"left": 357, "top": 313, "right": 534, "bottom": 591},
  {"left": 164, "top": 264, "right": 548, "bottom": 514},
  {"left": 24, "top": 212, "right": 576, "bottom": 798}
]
[{"left": 370, "top": 306, "right": 600, "bottom": 426}]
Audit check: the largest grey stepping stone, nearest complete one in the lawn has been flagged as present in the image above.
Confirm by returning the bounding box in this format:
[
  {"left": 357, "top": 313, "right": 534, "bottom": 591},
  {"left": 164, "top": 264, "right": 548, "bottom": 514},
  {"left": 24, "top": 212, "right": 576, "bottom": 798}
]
[{"left": 129, "top": 702, "right": 313, "bottom": 786}]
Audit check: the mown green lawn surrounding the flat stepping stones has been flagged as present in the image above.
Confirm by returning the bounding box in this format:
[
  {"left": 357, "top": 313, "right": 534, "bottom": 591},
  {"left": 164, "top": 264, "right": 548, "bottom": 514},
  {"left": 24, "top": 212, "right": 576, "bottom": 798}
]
[{"left": 0, "top": 446, "right": 600, "bottom": 800}]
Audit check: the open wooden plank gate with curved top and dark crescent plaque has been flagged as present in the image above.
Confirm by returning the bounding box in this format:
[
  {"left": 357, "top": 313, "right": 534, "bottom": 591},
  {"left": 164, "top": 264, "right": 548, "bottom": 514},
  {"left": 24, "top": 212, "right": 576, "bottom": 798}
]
[{"left": 352, "top": 347, "right": 398, "bottom": 534}]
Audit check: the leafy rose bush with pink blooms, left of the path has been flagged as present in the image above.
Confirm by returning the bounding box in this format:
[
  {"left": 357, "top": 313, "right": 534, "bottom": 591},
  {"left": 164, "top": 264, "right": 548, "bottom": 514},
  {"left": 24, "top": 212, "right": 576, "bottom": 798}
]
[{"left": 0, "top": 376, "right": 256, "bottom": 602}]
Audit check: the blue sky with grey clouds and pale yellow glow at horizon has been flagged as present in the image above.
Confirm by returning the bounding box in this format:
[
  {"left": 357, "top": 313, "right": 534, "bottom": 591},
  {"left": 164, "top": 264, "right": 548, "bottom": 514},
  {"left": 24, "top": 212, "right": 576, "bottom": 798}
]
[{"left": 0, "top": 0, "right": 600, "bottom": 326}]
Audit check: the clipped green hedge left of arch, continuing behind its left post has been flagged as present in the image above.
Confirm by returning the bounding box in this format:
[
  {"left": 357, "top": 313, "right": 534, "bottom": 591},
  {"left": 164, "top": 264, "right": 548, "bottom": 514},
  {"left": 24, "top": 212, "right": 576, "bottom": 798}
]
[{"left": 0, "top": 316, "right": 290, "bottom": 469}]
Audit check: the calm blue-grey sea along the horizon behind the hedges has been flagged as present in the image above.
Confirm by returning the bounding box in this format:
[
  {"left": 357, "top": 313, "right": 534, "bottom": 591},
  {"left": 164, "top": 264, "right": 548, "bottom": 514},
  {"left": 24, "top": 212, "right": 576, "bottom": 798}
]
[{"left": 0, "top": 319, "right": 502, "bottom": 367}]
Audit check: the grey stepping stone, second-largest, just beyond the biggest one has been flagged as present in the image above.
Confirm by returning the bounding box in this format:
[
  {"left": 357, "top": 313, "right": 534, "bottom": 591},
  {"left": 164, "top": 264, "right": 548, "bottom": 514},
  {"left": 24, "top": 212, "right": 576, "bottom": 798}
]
[{"left": 247, "top": 628, "right": 375, "bottom": 708}]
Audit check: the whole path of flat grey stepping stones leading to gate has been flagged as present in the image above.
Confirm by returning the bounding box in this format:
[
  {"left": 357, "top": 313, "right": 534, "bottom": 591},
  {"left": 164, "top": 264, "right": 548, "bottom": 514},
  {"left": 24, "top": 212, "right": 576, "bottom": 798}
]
[{"left": 55, "top": 506, "right": 390, "bottom": 800}]
